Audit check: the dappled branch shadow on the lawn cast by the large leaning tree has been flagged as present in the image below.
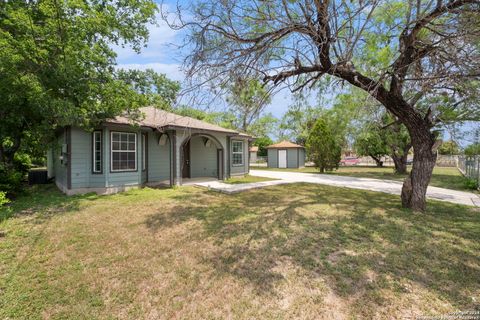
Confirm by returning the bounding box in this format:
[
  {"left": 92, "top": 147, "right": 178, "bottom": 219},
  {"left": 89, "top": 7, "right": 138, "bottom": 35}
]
[{"left": 146, "top": 184, "right": 480, "bottom": 310}]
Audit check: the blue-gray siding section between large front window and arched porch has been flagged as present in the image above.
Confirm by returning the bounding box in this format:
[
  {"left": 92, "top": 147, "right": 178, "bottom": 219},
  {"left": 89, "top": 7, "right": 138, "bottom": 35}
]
[{"left": 147, "top": 132, "right": 171, "bottom": 182}]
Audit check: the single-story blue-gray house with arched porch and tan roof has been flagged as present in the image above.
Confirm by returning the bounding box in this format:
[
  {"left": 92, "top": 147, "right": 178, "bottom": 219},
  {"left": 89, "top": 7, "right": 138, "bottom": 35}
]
[{"left": 47, "top": 107, "right": 251, "bottom": 194}]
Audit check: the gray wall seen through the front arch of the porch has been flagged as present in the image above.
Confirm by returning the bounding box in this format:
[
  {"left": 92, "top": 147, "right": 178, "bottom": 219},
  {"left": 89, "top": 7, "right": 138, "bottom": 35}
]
[{"left": 190, "top": 136, "right": 218, "bottom": 178}]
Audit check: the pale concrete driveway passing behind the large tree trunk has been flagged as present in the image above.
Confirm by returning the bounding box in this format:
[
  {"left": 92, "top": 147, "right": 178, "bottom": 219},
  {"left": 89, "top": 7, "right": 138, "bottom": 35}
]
[{"left": 250, "top": 170, "right": 480, "bottom": 206}]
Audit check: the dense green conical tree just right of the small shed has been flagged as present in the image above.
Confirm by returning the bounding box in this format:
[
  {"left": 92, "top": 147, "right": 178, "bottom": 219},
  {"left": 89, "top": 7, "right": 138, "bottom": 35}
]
[{"left": 306, "top": 118, "right": 342, "bottom": 173}]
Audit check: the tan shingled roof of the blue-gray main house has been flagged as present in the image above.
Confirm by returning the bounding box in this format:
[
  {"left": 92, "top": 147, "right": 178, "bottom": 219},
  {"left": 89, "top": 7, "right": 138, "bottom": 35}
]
[{"left": 107, "top": 107, "right": 250, "bottom": 137}]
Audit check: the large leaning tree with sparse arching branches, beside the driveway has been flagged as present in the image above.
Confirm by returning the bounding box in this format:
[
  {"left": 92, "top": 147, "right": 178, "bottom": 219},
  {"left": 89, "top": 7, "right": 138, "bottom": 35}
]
[{"left": 173, "top": 0, "right": 480, "bottom": 211}]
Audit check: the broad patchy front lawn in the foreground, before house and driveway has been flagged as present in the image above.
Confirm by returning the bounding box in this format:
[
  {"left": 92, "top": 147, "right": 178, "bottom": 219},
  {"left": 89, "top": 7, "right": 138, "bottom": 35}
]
[{"left": 0, "top": 184, "right": 480, "bottom": 319}]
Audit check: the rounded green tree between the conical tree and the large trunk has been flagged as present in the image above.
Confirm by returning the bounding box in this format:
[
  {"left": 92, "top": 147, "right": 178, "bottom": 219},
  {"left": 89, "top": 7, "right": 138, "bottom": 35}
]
[{"left": 354, "top": 126, "right": 390, "bottom": 167}]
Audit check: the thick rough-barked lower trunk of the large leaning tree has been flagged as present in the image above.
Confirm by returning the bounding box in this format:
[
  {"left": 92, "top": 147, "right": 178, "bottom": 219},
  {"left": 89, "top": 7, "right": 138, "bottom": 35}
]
[{"left": 402, "top": 124, "right": 437, "bottom": 211}]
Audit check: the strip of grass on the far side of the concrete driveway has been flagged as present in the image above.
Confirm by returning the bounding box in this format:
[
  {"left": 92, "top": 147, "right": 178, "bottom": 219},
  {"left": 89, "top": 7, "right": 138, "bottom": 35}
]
[{"left": 252, "top": 166, "right": 473, "bottom": 192}]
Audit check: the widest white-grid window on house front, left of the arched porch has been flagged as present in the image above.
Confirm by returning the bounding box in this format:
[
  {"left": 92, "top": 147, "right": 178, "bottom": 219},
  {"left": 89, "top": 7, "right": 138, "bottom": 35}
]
[{"left": 110, "top": 132, "right": 137, "bottom": 171}]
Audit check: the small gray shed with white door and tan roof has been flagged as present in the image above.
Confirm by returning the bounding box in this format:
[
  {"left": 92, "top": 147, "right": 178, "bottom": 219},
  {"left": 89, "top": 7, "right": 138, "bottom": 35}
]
[{"left": 267, "top": 140, "right": 305, "bottom": 168}]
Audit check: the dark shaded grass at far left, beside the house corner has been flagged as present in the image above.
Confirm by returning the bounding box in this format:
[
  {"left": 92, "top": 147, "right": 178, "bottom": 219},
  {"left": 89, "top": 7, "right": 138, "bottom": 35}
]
[{"left": 0, "top": 184, "right": 98, "bottom": 223}]
